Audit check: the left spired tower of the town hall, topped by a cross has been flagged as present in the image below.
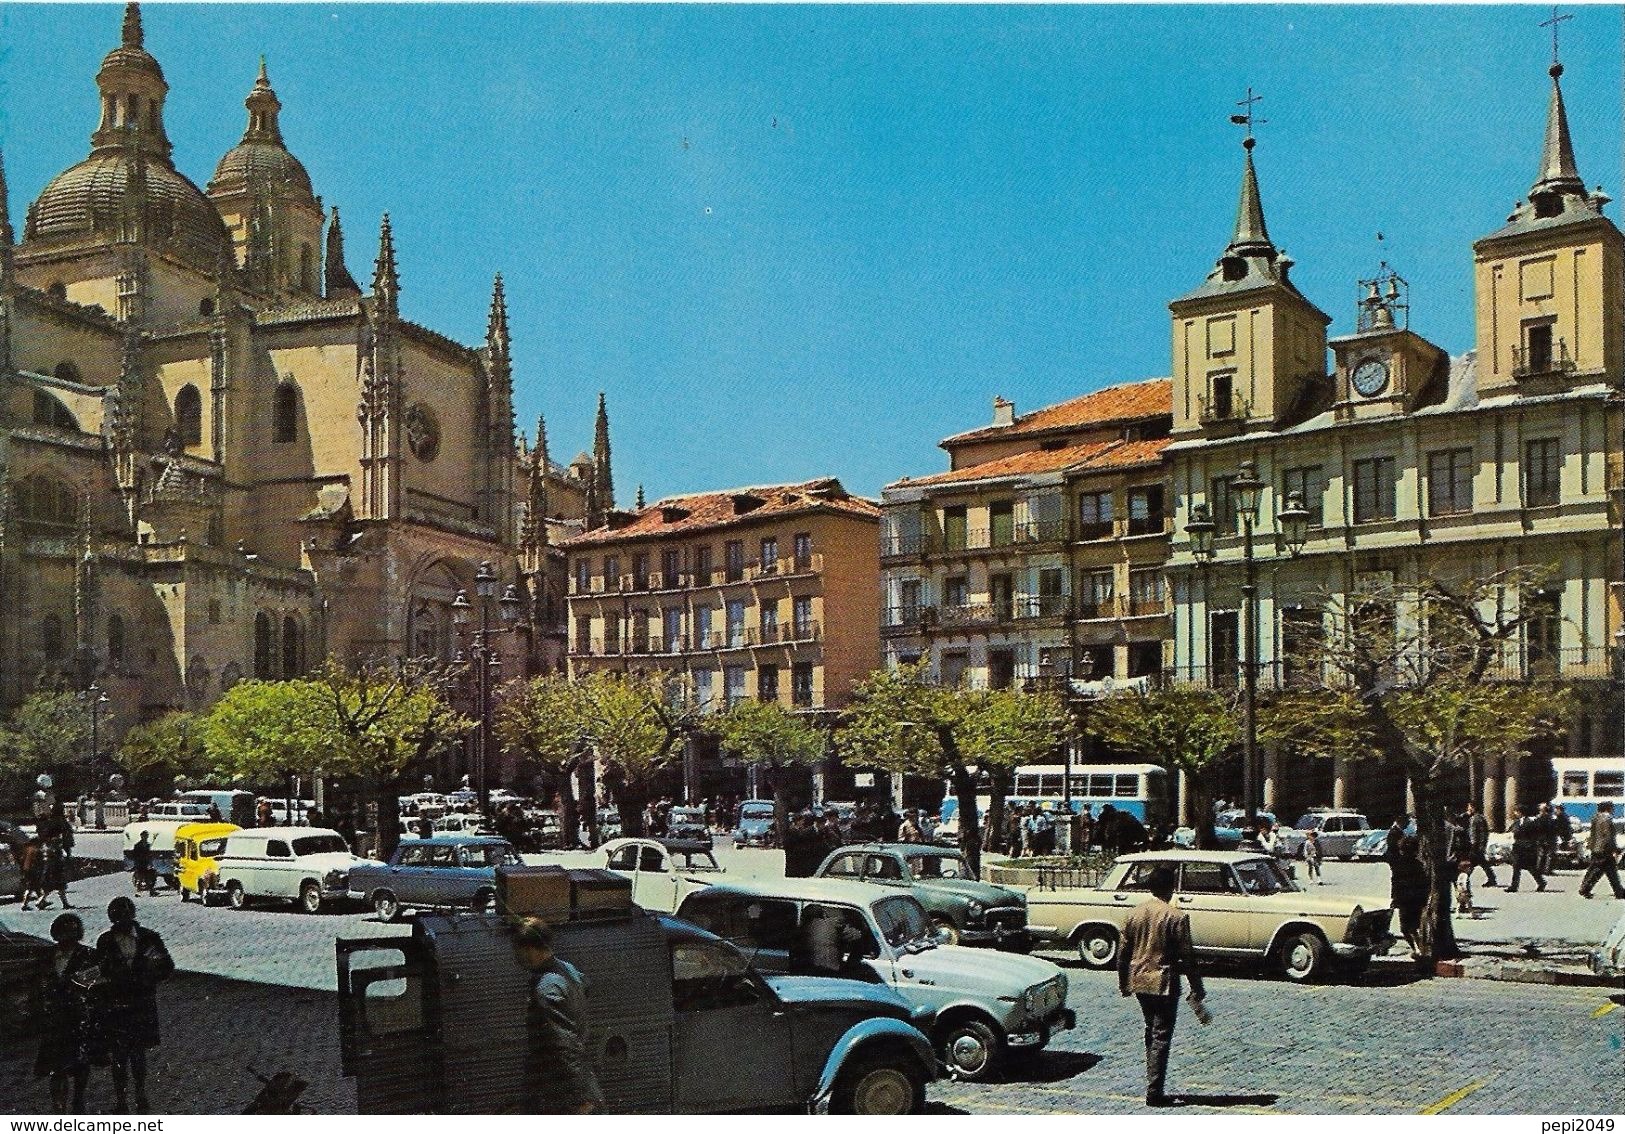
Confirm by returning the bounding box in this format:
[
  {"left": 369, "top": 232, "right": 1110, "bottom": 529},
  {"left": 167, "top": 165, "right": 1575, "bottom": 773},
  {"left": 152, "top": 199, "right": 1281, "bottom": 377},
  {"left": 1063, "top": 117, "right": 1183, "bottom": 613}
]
[{"left": 1168, "top": 88, "right": 1331, "bottom": 437}]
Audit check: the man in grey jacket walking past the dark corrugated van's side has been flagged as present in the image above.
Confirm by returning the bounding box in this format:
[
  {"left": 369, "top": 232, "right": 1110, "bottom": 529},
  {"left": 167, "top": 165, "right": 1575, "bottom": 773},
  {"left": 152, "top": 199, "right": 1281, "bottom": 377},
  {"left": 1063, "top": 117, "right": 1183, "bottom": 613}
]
[{"left": 514, "top": 918, "right": 605, "bottom": 1115}]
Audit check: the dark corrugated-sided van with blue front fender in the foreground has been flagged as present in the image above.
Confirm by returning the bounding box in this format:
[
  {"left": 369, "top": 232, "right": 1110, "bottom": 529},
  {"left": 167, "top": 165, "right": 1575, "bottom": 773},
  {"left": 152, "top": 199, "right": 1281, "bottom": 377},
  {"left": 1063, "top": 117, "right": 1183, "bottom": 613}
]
[{"left": 336, "top": 908, "right": 936, "bottom": 1115}]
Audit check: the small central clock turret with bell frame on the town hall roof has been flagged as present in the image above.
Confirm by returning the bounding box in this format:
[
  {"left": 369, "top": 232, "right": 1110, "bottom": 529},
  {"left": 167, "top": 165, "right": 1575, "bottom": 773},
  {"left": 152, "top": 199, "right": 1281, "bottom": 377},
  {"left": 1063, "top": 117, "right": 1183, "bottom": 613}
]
[{"left": 1329, "top": 263, "right": 1450, "bottom": 421}]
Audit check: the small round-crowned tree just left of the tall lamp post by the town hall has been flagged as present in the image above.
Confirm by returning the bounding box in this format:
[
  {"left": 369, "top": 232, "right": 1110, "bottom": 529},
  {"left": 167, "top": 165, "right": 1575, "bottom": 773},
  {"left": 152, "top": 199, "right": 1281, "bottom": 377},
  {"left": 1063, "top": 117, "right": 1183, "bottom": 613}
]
[{"left": 1087, "top": 686, "right": 1240, "bottom": 848}]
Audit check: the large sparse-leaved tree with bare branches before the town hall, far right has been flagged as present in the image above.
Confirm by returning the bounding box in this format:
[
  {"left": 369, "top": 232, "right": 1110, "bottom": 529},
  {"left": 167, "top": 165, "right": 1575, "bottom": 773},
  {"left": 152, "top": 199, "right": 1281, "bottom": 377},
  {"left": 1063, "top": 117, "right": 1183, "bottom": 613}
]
[{"left": 1268, "top": 567, "right": 1573, "bottom": 960}]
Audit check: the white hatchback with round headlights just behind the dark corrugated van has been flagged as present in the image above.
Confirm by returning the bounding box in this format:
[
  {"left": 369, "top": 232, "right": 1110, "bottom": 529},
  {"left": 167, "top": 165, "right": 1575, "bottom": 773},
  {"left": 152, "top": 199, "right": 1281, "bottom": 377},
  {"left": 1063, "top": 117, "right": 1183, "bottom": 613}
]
[{"left": 678, "top": 879, "right": 1076, "bottom": 1079}]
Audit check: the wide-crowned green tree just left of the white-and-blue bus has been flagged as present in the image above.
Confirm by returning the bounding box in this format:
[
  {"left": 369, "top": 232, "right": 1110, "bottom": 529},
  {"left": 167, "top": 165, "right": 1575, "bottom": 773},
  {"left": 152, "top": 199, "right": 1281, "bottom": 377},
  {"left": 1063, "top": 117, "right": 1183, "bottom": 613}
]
[{"left": 840, "top": 661, "right": 1071, "bottom": 871}]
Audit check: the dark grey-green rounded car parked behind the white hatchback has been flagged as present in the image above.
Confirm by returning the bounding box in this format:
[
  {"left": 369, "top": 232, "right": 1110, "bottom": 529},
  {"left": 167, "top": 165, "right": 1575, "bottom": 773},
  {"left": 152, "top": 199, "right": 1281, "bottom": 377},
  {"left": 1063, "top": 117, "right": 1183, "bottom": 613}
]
[{"left": 813, "top": 843, "right": 1030, "bottom": 949}]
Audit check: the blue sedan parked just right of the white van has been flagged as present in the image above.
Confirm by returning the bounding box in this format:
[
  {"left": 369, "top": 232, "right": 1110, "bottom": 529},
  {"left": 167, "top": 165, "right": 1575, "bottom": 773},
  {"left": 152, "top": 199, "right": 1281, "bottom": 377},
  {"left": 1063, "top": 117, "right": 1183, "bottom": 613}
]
[{"left": 348, "top": 835, "right": 523, "bottom": 921}]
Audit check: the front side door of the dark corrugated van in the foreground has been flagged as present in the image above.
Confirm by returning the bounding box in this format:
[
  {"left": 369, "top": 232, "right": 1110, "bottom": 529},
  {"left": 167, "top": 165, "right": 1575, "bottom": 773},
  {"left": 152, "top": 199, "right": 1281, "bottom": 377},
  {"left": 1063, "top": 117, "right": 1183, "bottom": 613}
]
[{"left": 671, "top": 941, "right": 798, "bottom": 1113}]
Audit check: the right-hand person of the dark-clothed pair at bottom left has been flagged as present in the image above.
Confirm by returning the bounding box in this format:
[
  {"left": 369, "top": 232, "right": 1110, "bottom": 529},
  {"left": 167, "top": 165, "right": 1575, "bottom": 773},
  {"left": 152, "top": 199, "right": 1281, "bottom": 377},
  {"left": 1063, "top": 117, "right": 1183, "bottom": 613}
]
[{"left": 96, "top": 897, "right": 176, "bottom": 1115}]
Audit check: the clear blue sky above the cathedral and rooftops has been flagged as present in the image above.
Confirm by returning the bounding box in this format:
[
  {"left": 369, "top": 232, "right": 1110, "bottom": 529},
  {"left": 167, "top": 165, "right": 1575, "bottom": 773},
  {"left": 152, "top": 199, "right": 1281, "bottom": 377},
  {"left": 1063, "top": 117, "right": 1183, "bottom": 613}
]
[{"left": 0, "top": 3, "right": 1622, "bottom": 504}]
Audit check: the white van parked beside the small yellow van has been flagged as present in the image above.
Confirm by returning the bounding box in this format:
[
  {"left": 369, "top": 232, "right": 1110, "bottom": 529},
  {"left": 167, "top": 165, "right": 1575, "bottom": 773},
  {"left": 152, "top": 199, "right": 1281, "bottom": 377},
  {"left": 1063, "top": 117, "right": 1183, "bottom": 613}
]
[{"left": 216, "top": 827, "right": 367, "bottom": 913}]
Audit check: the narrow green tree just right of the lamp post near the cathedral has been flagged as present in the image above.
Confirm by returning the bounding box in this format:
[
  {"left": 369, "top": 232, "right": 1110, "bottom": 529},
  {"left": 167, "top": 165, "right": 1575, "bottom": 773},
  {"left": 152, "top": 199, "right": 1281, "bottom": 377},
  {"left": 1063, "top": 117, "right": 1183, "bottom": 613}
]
[{"left": 494, "top": 673, "right": 596, "bottom": 848}]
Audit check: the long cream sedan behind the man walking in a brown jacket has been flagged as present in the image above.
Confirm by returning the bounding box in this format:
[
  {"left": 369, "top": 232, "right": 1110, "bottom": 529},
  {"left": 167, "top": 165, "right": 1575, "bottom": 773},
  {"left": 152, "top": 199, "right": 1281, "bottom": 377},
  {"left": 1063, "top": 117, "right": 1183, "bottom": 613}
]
[{"left": 1027, "top": 850, "right": 1393, "bottom": 981}]
